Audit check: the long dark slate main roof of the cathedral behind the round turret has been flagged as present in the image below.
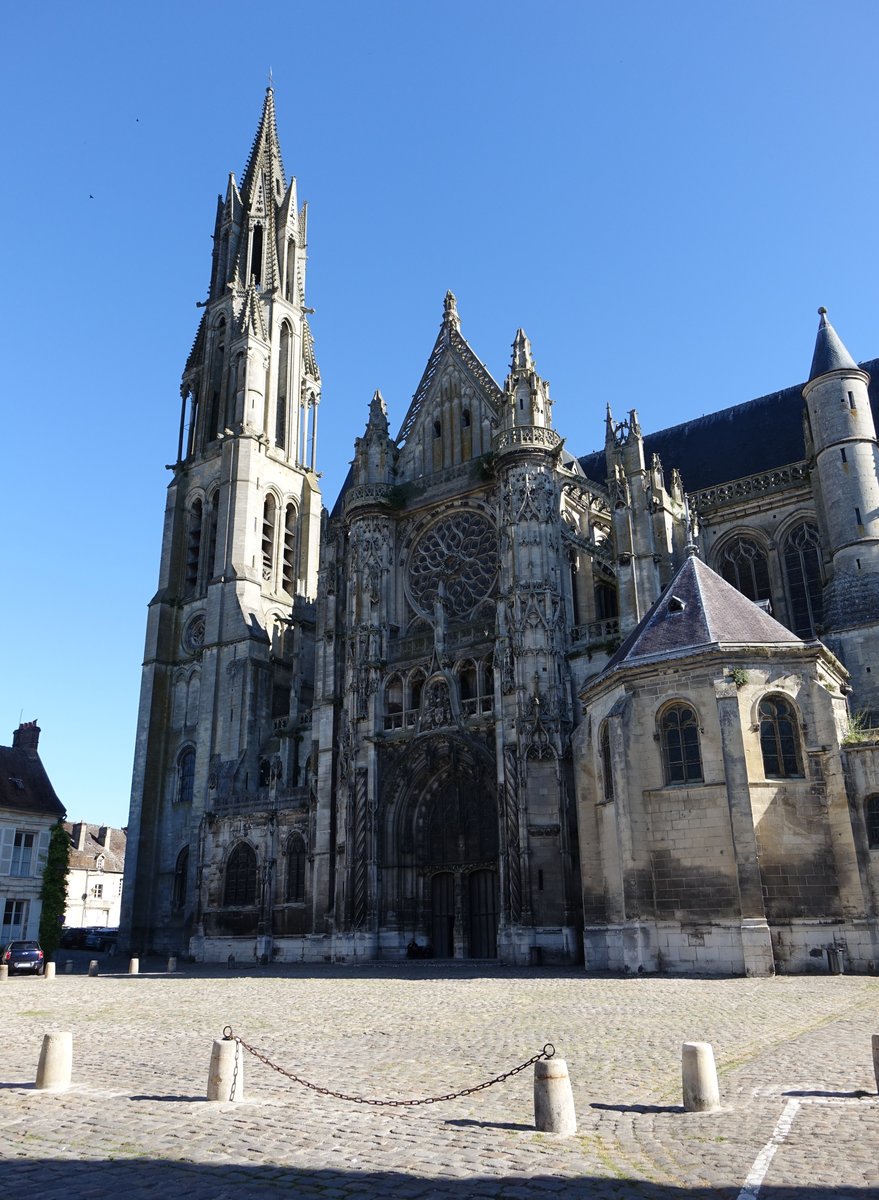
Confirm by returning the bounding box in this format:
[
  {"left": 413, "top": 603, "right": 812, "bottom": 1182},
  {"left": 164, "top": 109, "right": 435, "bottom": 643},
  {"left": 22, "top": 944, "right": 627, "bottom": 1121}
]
[{"left": 580, "top": 355, "right": 879, "bottom": 492}]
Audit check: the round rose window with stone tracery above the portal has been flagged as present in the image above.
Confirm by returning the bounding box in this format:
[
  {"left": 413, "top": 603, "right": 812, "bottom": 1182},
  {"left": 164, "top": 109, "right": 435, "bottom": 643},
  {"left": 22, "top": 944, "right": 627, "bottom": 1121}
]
[{"left": 408, "top": 509, "right": 497, "bottom": 620}]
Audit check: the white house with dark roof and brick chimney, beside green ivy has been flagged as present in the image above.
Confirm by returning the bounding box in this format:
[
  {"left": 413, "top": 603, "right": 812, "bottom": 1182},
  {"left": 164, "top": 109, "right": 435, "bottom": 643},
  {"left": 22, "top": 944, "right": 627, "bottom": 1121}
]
[{"left": 0, "top": 721, "right": 64, "bottom": 946}]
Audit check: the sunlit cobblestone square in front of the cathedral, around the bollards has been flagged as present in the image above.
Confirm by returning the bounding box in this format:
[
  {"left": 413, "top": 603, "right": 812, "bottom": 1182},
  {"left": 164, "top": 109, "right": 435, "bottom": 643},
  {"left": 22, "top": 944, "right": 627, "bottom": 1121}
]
[{"left": 0, "top": 960, "right": 879, "bottom": 1200}]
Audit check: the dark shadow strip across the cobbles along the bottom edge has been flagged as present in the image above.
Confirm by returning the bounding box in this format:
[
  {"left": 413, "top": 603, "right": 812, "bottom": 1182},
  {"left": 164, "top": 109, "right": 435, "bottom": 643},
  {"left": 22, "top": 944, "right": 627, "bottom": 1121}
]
[{"left": 4, "top": 1156, "right": 875, "bottom": 1200}]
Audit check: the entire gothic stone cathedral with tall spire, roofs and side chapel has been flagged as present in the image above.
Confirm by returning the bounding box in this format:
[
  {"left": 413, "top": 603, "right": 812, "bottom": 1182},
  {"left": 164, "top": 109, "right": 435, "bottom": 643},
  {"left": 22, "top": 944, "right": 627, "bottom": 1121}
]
[{"left": 122, "top": 89, "right": 879, "bottom": 974}]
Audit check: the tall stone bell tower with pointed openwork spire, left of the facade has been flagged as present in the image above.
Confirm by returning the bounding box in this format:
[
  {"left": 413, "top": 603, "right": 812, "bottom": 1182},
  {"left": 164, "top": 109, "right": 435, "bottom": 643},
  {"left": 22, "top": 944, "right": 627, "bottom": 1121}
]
[{"left": 122, "top": 88, "right": 321, "bottom": 950}]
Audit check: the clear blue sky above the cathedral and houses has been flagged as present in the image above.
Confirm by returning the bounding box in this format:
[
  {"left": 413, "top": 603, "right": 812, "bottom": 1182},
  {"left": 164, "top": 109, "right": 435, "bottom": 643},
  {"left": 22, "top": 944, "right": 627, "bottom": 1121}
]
[{"left": 0, "top": 0, "right": 879, "bottom": 826}]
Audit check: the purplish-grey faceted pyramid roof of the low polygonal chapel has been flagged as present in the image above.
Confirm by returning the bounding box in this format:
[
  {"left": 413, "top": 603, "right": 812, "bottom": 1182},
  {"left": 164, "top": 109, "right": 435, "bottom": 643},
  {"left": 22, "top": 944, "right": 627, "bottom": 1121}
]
[{"left": 603, "top": 554, "right": 803, "bottom": 674}]
